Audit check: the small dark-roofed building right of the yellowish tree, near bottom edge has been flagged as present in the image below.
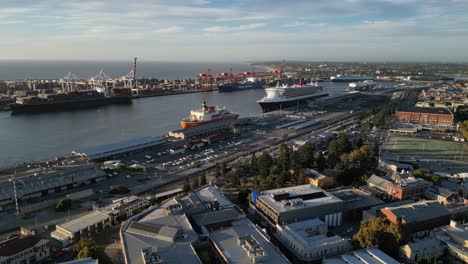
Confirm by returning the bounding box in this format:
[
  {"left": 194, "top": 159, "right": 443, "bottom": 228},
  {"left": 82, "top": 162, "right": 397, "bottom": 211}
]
[{"left": 399, "top": 238, "right": 445, "bottom": 263}]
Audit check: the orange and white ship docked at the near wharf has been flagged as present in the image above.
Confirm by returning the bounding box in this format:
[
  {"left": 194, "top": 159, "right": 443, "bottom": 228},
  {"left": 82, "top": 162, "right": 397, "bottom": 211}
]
[{"left": 180, "top": 101, "right": 239, "bottom": 128}]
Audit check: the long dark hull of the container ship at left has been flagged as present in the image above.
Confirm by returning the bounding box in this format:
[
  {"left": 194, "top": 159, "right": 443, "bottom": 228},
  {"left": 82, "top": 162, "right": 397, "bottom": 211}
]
[{"left": 10, "top": 96, "right": 132, "bottom": 113}]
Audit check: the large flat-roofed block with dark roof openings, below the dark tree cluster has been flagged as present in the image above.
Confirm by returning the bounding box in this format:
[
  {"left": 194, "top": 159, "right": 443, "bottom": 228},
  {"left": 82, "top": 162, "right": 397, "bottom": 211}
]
[{"left": 255, "top": 184, "right": 344, "bottom": 227}]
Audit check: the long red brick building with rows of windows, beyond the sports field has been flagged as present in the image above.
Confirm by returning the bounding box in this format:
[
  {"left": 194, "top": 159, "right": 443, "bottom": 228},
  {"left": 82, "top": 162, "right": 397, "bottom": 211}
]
[{"left": 395, "top": 107, "right": 453, "bottom": 126}]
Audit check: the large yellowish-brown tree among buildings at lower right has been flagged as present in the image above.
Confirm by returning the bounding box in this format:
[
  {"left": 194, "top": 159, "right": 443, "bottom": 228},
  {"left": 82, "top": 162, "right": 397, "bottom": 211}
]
[{"left": 353, "top": 217, "right": 408, "bottom": 255}]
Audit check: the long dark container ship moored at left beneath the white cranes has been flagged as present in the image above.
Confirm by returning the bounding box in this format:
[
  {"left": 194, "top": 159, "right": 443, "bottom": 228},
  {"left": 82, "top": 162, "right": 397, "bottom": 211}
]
[{"left": 9, "top": 89, "right": 132, "bottom": 113}]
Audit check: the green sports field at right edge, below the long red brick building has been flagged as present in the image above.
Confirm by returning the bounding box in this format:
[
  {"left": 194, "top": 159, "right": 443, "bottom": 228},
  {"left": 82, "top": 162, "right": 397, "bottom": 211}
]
[{"left": 384, "top": 135, "right": 468, "bottom": 162}]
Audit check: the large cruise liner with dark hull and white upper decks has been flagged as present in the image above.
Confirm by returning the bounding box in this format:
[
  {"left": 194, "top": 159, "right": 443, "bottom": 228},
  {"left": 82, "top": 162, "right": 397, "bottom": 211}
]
[{"left": 257, "top": 80, "right": 328, "bottom": 113}]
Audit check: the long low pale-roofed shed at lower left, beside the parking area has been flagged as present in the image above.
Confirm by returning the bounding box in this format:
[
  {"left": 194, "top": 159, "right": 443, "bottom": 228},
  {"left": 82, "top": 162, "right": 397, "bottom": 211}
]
[{"left": 50, "top": 211, "right": 112, "bottom": 246}]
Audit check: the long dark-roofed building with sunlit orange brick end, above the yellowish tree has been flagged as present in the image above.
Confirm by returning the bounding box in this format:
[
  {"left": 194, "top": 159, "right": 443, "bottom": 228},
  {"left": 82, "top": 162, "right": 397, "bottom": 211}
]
[{"left": 380, "top": 201, "right": 451, "bottom": 237}]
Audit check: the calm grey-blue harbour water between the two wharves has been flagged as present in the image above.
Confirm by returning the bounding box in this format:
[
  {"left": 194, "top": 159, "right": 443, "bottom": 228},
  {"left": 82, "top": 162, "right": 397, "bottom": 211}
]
[{"left": 0, "top": 59, "right": 358, "bottom": 168}]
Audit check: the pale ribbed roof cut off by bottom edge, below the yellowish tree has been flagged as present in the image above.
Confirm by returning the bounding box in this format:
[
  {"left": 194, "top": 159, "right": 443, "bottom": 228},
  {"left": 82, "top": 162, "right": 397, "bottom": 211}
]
[{"left": 322, "top": 248, "right": 400, "bottom": 264}]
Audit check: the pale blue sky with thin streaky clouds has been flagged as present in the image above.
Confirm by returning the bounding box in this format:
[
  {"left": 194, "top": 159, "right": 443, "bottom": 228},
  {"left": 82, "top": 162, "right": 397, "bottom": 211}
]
[{"left": 0, "top": 0, "right": 468, "bottom": 62}]
